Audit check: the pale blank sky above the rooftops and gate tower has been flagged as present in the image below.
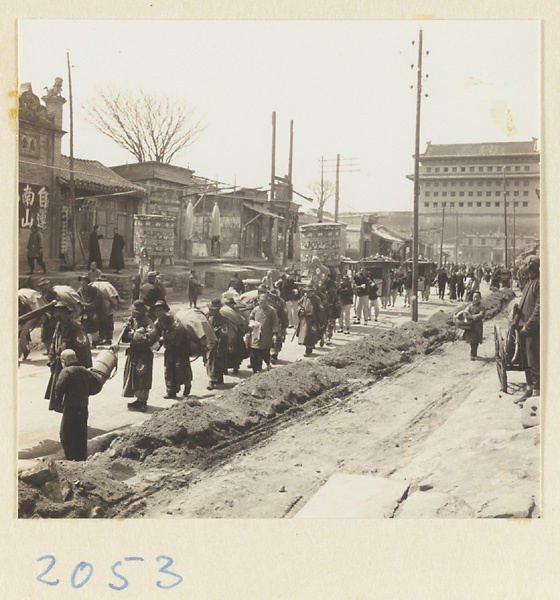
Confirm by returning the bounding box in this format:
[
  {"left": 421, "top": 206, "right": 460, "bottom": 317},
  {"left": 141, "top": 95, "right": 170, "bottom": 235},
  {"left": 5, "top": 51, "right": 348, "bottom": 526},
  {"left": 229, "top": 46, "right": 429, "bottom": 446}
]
[{"left": 19, "top": 20, "right": 540, "bottom": 211}]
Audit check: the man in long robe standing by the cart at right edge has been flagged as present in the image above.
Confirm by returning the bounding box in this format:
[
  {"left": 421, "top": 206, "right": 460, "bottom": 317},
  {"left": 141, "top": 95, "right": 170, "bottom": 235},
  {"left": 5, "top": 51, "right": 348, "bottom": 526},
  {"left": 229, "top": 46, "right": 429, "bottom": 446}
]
[{"left": 514, "top": 255, "right": 541, "bottom": 404}]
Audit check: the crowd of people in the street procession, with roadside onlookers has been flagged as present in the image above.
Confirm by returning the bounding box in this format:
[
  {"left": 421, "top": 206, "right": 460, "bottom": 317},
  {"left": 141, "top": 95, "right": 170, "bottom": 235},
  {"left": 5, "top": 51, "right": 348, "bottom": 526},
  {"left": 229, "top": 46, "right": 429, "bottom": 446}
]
[{"left": 19, "top": 251, "right": 540, "bottom": 460}]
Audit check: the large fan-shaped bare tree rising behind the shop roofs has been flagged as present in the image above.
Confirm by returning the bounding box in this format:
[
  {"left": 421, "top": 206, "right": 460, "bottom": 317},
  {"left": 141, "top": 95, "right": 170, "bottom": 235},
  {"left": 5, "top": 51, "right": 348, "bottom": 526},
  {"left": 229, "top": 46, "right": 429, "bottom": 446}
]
[{"left": 83, "top": 88, "right": 206, "bottom": 163}]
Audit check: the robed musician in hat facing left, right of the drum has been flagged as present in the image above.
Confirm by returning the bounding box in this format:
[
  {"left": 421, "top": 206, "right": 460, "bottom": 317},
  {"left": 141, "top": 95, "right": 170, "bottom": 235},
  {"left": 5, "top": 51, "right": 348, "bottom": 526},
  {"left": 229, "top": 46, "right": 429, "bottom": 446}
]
[{"left": 121, "top": 300, "right": 157, "bottom": 412}]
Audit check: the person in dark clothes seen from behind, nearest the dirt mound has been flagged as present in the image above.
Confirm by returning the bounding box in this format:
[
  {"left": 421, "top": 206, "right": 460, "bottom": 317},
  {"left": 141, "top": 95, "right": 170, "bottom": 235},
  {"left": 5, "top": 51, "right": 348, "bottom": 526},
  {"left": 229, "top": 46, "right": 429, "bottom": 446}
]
[{"left": 54, "top": 349, "right": 101, "bottom": 460}]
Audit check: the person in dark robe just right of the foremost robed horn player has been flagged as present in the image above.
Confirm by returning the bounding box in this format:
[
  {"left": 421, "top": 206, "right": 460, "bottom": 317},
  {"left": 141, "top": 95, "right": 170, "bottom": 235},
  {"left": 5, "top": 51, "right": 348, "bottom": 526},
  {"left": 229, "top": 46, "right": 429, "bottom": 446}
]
[{"left": 154, "top": 300, "right": 193, "bottom": 398}]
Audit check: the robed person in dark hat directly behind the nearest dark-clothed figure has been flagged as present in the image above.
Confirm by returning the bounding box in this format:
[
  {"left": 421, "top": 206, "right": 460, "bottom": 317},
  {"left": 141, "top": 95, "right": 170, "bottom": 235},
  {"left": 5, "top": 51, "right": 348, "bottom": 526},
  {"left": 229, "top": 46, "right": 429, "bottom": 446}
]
[{"left": 45, "top": 302, "right": 91, "bottom": 410}]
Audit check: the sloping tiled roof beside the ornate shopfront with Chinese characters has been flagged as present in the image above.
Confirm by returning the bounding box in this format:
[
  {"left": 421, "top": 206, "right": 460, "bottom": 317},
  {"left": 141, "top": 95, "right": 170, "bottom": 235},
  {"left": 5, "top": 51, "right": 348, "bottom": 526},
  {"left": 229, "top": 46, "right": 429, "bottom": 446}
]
[{"left": 60, "top": 156, "right": 146, "bottom": 195}]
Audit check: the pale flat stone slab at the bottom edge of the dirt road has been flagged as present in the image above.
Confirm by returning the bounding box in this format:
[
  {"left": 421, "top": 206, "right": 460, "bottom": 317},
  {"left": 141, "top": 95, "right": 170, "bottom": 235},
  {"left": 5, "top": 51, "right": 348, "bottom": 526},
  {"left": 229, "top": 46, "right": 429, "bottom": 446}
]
[{"left": 294, "top": 473, "right": 410, "bottom": 519}]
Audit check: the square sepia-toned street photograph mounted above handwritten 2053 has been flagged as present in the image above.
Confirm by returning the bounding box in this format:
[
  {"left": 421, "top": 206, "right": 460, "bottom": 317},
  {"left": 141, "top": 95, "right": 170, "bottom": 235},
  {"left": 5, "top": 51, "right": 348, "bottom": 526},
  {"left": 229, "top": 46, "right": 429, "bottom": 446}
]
[{"left": 14, "top": 19, "right": 540, "bottom": 524}]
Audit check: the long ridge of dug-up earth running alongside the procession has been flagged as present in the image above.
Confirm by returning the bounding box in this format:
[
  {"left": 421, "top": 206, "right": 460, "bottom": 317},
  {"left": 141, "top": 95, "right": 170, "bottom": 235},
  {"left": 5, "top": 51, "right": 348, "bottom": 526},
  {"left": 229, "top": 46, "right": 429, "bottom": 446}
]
[{"left": 19, "top": 290, "right": 513, "bottom": 518}]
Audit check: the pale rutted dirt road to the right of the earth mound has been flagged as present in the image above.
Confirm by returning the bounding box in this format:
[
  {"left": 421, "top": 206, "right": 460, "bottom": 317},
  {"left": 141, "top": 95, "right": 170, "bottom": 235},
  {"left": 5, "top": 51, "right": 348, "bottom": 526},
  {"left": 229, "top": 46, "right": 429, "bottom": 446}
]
[{"left": 143, "top": 314, "right": 540, "bottom": 518}]
